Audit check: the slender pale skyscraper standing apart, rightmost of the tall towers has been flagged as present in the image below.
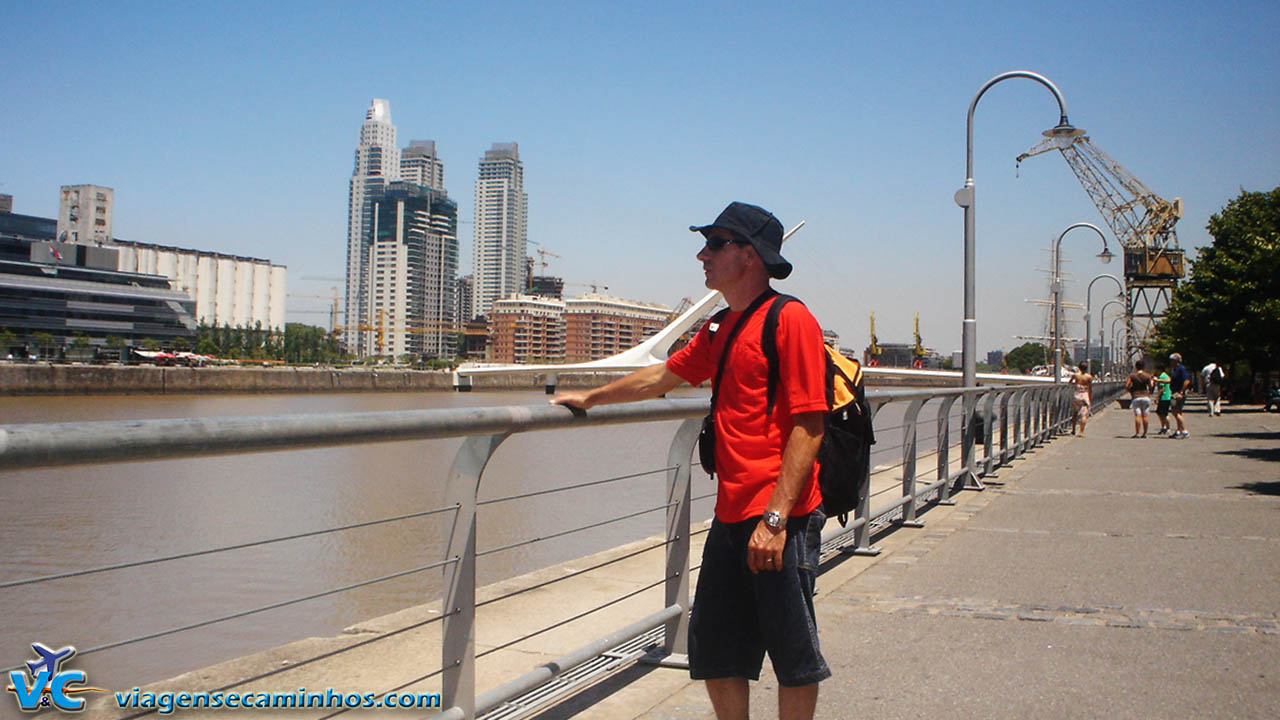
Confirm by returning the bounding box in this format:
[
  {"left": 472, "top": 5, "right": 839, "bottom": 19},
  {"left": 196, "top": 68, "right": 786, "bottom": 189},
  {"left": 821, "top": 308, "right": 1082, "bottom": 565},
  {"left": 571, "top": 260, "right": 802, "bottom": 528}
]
[{"left": 471, "top": 142, "right": 529, "bottom": 315}]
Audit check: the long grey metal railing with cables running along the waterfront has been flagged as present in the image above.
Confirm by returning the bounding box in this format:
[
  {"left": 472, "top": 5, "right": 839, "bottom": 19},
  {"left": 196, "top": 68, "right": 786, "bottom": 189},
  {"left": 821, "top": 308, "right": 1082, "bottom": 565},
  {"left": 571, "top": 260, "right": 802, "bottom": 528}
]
[{"left": 0, "top": 383, "right": 1121, "bottom": 719}]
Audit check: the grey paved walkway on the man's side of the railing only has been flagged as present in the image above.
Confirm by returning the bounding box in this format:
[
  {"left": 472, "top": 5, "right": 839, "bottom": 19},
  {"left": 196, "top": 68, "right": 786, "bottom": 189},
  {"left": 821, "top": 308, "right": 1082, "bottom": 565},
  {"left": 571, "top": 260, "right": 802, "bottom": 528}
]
[{"left": 568, "top": 404, "right": 1280, "bottom": 720}]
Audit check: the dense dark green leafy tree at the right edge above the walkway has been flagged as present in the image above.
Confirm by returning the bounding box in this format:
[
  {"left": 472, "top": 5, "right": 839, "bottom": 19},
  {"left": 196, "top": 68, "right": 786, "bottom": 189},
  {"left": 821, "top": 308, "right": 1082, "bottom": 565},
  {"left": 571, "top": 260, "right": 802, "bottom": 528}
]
[{"left": 1148, "top": 187, "right": 1280, "bottom": 372}]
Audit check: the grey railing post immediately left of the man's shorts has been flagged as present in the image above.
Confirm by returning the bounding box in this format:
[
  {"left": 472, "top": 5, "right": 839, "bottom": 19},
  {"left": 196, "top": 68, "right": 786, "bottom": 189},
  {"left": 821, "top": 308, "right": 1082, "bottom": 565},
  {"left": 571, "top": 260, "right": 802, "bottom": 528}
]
[{"left": 646, "top": 418, "right": 703, "bottom": 667}]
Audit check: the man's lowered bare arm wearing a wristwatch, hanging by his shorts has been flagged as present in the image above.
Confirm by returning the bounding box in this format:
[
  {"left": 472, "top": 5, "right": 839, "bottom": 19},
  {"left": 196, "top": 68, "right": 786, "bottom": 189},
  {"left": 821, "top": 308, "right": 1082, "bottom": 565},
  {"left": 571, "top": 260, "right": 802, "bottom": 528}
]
[{"left": 746, "top": 413, "right": 824, "bottom": 573}]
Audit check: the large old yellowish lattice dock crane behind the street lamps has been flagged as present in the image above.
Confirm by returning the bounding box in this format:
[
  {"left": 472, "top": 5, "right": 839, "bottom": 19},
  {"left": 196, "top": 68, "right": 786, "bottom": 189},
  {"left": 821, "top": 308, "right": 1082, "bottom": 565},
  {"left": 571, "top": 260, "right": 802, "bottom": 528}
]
[{"left": 1016, "top": 126, "right": 1184, "bottom": 354}]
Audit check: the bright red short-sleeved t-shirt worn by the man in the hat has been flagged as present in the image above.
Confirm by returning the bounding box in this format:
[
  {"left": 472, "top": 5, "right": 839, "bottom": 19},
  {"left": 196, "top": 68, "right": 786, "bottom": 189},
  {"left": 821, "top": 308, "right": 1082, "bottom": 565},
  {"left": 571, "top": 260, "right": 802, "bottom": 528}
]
[{"left": 667, "top": 300, "right": 827, "bottom": 523}]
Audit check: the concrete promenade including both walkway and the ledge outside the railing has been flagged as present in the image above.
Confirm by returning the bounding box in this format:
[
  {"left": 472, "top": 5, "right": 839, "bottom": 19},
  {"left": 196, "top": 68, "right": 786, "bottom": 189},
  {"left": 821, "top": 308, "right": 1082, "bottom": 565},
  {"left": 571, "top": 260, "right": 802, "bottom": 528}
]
[{"left": 74, "top": 401, "right": 1280, "bottom": 720}]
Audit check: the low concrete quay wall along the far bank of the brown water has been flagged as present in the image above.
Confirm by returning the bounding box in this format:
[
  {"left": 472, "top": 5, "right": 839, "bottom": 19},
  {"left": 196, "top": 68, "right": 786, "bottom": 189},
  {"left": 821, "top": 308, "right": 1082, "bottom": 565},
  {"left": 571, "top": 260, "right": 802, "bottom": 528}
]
[{"left": 0, "top": 363, "right": 600, "bottom": 396}]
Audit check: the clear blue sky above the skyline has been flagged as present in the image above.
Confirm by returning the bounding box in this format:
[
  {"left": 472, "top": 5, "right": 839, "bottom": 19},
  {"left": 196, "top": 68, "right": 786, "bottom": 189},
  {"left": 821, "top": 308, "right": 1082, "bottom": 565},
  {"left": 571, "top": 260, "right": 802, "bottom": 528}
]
[{"left": 0, "top": 0, "right": 1280, "bottom": 354}]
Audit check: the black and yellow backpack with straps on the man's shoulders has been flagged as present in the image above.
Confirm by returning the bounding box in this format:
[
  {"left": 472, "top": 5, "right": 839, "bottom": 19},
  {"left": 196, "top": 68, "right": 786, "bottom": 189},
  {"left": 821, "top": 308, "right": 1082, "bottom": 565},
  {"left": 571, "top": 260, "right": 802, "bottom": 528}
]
[{"left": 699, "top": 293, "right": 876, "bottom": 525}]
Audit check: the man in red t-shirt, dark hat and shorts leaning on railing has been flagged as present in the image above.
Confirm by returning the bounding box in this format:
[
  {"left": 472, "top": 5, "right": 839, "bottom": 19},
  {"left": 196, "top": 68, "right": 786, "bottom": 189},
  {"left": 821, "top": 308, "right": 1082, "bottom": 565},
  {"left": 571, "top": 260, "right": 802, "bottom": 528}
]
[{"left": 552, "top": 202, "right": 831, "bottom": 720}]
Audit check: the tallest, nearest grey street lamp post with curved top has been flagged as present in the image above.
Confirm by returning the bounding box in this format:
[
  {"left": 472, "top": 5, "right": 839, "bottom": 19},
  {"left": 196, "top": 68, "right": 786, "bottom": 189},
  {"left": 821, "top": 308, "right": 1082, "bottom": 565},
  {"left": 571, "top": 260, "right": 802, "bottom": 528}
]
[{"left": 955, "top": 70, "right": 1083, "bottom": 477}]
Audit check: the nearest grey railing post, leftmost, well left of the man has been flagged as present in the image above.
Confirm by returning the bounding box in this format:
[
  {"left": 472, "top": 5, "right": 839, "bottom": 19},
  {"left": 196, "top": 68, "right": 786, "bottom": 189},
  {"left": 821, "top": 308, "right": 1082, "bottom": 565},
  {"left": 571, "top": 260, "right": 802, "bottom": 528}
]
[{"left": 440, "top": 433, "right": 509, "bottom": 720}]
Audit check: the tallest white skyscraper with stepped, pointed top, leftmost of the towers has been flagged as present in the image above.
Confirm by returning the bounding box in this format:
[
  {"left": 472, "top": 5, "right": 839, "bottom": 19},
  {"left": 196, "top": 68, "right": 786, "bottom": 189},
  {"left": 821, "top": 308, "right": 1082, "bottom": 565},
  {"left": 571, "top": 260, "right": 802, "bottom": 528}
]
[{"left": 343, "top": 97, "right": 399, "bottom": 356}]
